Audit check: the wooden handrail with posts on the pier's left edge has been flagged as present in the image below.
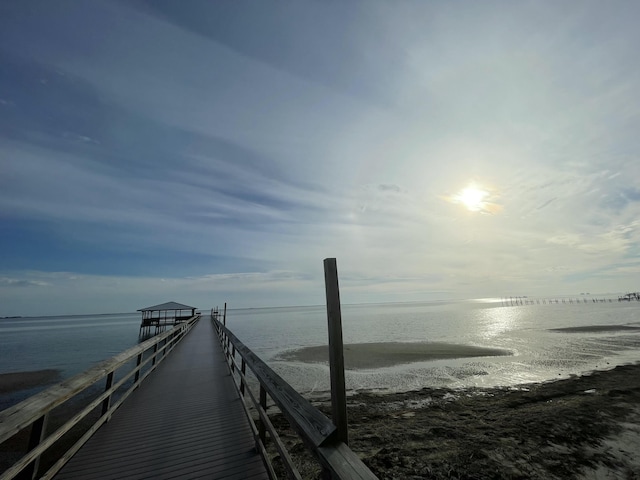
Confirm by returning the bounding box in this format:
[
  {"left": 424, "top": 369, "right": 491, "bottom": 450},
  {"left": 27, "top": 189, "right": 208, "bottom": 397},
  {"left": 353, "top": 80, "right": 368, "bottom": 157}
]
[{"left": 0, "top": 315, "right": 200, "bottom": 480}]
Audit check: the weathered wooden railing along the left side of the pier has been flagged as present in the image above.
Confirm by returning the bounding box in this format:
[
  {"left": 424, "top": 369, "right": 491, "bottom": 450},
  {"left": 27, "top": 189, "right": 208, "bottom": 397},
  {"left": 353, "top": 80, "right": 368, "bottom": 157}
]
[{"left": 0, "top": 315, "right": 200, "bottom": 480}]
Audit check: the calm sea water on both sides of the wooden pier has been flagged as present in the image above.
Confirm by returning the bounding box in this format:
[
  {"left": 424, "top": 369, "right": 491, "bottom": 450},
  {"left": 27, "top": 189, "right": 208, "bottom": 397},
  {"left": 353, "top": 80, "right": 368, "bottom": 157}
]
[{"left": 0, "top": 300, "right": 640, "bottom": 405}]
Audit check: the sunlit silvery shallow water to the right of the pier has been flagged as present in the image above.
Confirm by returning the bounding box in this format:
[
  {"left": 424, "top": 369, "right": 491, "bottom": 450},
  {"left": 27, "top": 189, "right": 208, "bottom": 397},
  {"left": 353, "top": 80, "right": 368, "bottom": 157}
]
[{"left": 227, "top": 299, "right": 640, "bottom": 394}]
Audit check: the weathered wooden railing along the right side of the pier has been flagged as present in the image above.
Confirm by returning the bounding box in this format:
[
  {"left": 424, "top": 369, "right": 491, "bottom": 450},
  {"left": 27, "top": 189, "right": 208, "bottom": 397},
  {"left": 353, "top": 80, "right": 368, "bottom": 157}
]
[{"left": 211, "top": 311, "right": 377, "bottom": 480}]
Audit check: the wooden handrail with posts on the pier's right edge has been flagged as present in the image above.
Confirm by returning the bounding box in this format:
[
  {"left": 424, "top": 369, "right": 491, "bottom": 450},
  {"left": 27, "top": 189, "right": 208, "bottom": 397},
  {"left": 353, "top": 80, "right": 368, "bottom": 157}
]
[{"left": 211, "top": 312, "right": 378, "bottom": 480}]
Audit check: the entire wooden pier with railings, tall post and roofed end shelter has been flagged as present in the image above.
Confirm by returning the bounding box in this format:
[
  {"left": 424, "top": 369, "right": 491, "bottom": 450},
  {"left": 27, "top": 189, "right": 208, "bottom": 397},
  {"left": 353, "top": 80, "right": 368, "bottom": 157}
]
[{"left": 0, "top": 259, "right": 377, "bottom": 480}]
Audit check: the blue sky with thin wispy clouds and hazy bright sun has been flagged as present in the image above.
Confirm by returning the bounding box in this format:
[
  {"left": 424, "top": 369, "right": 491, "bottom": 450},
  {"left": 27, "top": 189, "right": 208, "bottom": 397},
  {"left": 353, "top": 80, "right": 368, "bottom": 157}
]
[{"left": 0, "top": 0, "right": 640, "bottom": 316}]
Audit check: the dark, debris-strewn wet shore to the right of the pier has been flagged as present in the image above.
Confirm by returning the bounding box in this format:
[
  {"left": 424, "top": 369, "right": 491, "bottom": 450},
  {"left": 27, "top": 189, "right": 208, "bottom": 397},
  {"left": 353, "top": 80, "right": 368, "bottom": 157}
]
[{"left": 273, "top": 365, "right": 640, "bottom": 480}]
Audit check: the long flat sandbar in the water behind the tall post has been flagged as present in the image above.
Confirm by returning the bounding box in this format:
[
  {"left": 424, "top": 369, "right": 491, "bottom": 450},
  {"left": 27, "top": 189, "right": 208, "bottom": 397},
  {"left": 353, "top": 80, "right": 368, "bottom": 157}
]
[{"left": 276, "top": 342, "right": 512, "bottom": 369}]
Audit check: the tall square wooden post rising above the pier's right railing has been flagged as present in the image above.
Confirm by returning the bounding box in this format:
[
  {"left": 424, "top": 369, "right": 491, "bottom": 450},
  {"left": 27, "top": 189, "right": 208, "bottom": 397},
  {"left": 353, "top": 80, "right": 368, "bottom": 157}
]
[{"left": 324, "top": 258, "right": 349, "bottom": 444}]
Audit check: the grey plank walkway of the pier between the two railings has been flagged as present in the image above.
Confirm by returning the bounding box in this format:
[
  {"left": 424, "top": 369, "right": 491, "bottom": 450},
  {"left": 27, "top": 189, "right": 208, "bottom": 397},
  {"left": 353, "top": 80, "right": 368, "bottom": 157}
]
[{"left": 55, "top": 316, "right": 269, "bottom": 480}]
